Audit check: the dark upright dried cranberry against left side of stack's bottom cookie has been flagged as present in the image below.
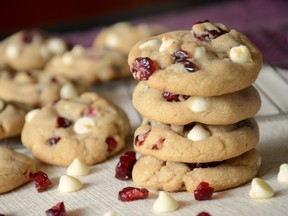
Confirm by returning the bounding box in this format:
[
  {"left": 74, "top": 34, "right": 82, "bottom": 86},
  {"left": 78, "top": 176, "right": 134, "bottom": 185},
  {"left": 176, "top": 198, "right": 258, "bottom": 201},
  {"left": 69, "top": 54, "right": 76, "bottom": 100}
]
[{"left": 115, "top": 151, "right": 136, "bottom": 180}]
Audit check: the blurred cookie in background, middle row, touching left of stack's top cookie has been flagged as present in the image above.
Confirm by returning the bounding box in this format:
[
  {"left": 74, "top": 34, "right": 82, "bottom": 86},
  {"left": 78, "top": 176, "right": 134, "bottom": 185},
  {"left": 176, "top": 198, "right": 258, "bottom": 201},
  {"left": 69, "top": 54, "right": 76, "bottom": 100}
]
[{"left": 45, "top": 45, "right": 131, "bottom": 85}]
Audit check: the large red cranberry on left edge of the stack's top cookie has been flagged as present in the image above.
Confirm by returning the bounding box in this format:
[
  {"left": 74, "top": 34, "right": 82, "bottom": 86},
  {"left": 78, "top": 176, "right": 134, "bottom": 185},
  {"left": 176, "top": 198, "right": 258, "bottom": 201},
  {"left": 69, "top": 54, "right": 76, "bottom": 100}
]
[{"left": 132, "top": 57, "right": 157, "bottom": 81}]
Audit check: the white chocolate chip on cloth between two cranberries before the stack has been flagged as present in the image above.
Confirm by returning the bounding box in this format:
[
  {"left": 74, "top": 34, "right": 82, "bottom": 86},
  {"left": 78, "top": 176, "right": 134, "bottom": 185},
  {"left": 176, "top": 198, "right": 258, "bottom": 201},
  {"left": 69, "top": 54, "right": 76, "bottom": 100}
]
[{"left": 153, "top": 191, "right": 179, "bottom": 213}]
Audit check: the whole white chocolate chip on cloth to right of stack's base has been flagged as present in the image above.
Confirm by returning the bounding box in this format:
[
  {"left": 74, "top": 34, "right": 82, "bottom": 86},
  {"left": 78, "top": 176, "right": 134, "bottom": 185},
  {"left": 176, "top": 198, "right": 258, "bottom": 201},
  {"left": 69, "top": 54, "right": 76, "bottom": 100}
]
[{"left": 249, "top": 178, "right": 275, "bottom": 199}]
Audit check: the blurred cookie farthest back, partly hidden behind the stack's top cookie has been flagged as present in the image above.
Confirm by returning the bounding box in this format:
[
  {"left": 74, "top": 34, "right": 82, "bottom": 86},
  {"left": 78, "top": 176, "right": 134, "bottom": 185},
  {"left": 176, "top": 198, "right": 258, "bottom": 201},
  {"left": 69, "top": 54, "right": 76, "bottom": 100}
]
[{"left": 93, "top": 22, "right": 166, "bottom": 55}]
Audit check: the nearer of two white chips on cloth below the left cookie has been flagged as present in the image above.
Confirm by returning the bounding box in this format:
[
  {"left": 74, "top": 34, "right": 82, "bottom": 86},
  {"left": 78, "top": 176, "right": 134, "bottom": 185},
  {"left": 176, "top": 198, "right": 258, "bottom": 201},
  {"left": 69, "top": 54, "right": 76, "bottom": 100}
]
[{"left": 58, "top": 175, "right": 83, "bottom": 193}]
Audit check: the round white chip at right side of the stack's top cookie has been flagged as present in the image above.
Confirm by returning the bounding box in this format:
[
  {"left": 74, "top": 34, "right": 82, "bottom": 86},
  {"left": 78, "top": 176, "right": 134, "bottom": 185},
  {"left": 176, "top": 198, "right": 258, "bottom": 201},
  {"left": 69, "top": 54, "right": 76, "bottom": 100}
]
[{"left": 229, "top": 45, "right": 251, "bottom": 64}]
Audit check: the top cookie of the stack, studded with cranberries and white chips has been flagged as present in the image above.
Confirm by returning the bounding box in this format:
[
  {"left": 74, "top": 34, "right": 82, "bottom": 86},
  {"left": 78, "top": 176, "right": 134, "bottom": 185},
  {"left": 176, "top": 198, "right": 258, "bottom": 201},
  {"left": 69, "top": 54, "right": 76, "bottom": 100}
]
[{"left": 128, "top": 21, "right": 262, "bottom": 97}]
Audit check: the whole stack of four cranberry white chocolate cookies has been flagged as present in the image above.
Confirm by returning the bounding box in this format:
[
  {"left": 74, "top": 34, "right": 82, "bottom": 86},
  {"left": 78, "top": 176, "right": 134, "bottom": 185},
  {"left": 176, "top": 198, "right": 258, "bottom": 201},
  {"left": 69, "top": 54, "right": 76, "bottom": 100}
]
[{"left": 128, "top": 21, "right": 262, "bottom": 191}]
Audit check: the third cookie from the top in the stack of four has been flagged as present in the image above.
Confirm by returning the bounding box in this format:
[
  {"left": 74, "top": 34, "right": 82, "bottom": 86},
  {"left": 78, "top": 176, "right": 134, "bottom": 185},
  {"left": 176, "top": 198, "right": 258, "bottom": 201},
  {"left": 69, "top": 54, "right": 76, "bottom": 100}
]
[{"left": 134, "top": 118, "right": 259, "bottom": 163}]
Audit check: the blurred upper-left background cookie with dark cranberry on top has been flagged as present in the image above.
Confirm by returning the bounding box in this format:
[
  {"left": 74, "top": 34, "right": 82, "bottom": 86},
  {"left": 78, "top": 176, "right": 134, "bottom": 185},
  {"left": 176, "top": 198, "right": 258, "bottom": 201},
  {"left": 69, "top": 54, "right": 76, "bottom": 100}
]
[{"left": 0, "top": 29, "right": 67, "bottom": 71}]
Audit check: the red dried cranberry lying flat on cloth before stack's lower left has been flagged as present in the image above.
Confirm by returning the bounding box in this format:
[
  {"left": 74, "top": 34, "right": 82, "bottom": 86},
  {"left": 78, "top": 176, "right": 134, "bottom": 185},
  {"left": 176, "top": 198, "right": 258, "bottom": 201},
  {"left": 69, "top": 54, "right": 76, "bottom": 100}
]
[{"left": 118, "top": 187, "right": 149, "bottom": 202}]
